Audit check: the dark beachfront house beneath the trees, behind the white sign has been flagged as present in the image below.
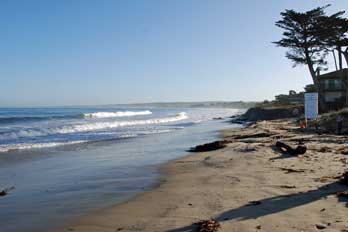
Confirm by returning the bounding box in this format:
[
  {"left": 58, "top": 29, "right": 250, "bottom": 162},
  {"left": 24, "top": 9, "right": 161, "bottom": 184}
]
[{"left": 319, "top": 68, "right": 348, "bottom": 110}]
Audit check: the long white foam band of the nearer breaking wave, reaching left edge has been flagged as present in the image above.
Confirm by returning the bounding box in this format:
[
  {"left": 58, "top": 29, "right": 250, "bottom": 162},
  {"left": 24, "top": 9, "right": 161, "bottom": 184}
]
[{"left": 0, "top": 112, "right": 188, "bottom": 140}]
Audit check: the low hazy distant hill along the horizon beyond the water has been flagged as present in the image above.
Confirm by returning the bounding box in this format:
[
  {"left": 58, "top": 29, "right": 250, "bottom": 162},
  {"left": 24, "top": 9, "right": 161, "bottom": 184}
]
[{"left": 111, "top": 101, "right": 257, "bottom": 109}]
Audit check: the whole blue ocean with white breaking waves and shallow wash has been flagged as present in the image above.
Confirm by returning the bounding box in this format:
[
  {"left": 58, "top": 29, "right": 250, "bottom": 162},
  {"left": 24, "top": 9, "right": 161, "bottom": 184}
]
[{"left": 0, "top": 106, "right": 243, "bottom": 232}]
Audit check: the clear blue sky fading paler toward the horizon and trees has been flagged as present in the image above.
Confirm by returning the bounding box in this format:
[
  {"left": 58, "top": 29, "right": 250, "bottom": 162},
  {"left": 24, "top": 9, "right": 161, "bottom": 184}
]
[{"left": 0, "top": 0, "right": 348, "bottom": 106}]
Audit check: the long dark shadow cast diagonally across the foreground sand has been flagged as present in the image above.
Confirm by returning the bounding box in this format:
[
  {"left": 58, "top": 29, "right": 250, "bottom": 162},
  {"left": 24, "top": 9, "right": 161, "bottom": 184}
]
[{"left": 168, "top": 182, "right": 347, "bottom": 232}]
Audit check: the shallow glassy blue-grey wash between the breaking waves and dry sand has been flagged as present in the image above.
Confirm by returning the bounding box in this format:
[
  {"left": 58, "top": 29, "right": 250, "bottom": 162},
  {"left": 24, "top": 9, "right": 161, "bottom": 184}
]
[{"left": 0, "top": 109, "right": 239, "bottom": 232}]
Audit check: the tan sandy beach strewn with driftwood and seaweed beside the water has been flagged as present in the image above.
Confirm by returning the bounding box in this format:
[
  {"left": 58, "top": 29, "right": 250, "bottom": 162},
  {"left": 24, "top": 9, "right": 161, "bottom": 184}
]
[{"left": 59, "top": 120, "right": 348, "bottom": 232}]
